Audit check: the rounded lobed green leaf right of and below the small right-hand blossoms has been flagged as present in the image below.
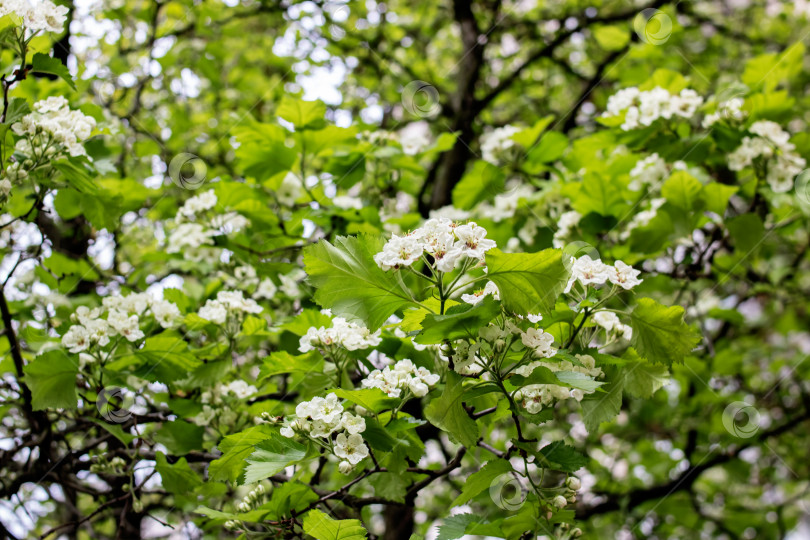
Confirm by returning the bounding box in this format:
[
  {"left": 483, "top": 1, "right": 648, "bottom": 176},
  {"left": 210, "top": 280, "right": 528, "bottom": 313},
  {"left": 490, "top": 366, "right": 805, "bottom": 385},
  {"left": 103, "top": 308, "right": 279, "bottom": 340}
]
[{"left": 630, "top": 298, "right": 700, "bottom": 366}]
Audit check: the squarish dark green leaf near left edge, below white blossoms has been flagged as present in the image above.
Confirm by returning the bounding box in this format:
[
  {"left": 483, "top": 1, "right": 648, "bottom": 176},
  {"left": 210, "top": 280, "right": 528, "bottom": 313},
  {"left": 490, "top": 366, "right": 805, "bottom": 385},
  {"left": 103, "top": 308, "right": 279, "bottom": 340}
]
[{"left": 23, "top": 349, "right": 79, "bottom": 411}]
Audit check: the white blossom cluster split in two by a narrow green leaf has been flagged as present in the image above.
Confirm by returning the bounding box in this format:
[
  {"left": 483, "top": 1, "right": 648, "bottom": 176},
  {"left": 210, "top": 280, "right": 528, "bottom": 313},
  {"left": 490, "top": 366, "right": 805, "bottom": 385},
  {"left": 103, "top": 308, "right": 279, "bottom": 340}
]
[{"left": 515, "top": 354, "right": 604, "bottom": 414}]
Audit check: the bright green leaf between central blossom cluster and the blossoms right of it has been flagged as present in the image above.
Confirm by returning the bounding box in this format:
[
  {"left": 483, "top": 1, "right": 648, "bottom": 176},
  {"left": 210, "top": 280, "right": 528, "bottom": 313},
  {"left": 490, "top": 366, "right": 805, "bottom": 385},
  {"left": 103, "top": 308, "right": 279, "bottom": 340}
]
[{"left": 486, "top": 249, "right": 569, "bottom": 315}]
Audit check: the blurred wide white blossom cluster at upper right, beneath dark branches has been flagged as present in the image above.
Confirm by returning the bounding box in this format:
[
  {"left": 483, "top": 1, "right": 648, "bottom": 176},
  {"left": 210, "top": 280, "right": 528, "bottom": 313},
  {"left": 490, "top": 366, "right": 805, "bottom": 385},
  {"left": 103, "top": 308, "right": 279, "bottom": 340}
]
[{"left": 604, "top": 86, "right": 703, "bottom": 131}]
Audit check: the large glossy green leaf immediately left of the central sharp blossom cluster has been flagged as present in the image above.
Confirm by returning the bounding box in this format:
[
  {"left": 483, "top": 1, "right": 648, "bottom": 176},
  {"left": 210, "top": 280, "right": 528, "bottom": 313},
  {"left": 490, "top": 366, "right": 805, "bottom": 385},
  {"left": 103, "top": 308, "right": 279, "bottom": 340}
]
[{"left": 304, "top": 235, "right": 419, "bottom": 331}]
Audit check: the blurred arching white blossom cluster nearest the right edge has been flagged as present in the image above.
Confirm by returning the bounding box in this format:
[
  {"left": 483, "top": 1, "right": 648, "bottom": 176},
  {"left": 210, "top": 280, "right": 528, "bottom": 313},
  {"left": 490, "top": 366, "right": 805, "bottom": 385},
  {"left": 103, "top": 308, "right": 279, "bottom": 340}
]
[{"left": 728, "top": 120, "right": 806, "bottom": 193}]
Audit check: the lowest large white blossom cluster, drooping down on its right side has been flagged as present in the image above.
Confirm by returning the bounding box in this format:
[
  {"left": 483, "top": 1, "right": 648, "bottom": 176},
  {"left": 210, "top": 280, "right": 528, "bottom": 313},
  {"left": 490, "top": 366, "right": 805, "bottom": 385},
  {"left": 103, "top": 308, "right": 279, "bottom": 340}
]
[{"left": 281, "top": 393, "right": 369, "bottom": 474}]
